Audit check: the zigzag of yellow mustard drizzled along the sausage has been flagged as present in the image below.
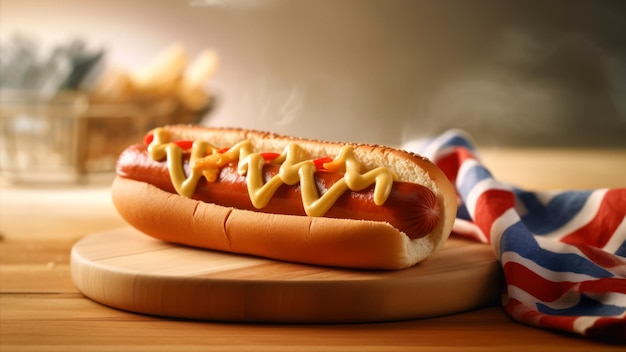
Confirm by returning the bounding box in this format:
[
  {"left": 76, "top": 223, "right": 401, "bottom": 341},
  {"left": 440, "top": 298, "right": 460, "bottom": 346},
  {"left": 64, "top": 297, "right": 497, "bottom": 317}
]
[{"left": 148, "top": 128, "right": 394, "bottom": 216}]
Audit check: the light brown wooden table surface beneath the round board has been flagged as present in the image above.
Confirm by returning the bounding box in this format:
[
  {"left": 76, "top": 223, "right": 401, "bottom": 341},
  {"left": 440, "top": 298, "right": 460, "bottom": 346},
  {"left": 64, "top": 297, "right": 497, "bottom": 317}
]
[{"left": 0, "top": 149, "right": 626, "bottom": 352}]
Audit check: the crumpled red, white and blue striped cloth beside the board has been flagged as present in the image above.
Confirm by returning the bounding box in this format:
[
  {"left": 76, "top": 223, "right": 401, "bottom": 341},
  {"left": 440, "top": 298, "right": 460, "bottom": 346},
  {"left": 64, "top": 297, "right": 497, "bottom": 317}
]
[{"left": 404, "top": 130, "right": 626, "bottom": 340}]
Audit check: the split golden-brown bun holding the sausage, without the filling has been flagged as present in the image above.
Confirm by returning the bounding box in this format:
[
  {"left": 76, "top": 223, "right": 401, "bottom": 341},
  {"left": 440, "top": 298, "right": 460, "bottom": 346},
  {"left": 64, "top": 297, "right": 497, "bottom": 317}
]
[{"left": 112, "top": 125, "right": 457, "bottom": 270}]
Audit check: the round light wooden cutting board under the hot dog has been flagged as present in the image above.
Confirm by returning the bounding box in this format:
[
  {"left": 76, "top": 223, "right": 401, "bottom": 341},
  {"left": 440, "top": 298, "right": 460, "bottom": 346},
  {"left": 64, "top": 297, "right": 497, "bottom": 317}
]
[{"left": 71, "top": 228, "right": 502, "bottom": 323}]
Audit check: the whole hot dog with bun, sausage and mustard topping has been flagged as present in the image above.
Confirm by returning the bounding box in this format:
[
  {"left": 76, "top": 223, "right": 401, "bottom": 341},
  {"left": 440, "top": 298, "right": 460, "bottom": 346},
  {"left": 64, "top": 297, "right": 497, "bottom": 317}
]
[{"left": 112, "top": 125, "right": 456, "bottom": 269}]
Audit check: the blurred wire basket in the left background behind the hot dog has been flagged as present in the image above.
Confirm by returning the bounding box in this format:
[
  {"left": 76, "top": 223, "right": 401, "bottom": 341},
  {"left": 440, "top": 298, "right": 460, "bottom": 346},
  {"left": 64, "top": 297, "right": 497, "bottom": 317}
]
[{"left": 0, "top": 91, "right": 209, "bottom": 183}]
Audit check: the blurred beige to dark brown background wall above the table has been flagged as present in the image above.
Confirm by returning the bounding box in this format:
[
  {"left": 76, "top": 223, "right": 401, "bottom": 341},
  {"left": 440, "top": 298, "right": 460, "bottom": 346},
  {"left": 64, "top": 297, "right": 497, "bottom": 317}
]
[{"left": 0, "top": 0, "right": 626, "bottom": 182}]
